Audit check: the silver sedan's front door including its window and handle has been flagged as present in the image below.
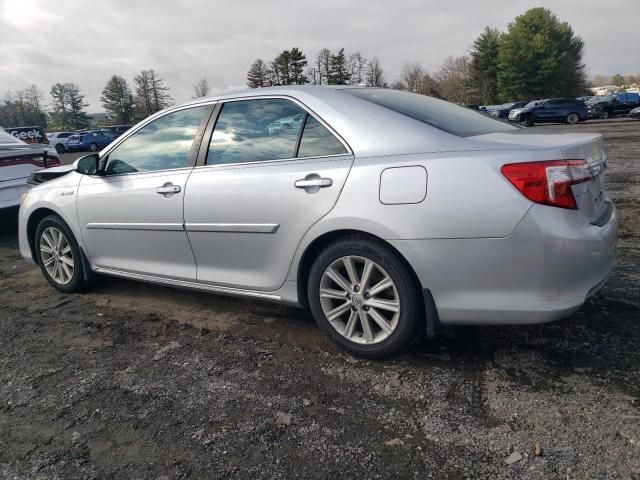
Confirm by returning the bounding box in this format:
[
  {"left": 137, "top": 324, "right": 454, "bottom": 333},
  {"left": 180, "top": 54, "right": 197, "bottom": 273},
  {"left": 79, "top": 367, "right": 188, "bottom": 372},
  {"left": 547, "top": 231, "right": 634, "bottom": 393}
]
[{"left": 77, "top": 106, "right": 212, "bottom": 280}]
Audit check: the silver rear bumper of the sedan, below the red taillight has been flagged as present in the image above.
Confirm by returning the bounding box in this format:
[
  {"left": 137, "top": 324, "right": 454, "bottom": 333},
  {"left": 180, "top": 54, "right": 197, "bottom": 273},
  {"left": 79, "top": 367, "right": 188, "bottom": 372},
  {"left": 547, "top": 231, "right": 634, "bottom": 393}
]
[{"left": 391, "top": 205, "right": 618, "bottom": 325}]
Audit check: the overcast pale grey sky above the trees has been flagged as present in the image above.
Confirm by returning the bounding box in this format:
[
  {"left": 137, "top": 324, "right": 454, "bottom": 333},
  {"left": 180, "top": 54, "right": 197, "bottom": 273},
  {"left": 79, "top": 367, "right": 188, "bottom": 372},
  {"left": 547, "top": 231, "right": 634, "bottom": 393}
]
[{"left": 0, "top": 0, "right": 640, "bottom": 112}]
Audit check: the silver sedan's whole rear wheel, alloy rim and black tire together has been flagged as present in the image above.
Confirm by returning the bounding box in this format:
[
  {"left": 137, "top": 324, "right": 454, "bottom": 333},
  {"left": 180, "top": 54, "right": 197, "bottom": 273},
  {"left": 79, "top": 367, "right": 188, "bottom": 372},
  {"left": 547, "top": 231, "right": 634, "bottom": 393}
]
[{"left": 307, "top": 236, "right": 424, "bottom": 358}]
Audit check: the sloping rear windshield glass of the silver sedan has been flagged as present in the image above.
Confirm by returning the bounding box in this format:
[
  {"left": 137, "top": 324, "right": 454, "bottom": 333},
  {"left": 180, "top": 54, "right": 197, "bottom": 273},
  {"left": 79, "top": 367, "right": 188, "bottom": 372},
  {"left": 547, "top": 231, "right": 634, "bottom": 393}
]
[{"left": 342, "top": 88, "right": 518, "bottom": 137}]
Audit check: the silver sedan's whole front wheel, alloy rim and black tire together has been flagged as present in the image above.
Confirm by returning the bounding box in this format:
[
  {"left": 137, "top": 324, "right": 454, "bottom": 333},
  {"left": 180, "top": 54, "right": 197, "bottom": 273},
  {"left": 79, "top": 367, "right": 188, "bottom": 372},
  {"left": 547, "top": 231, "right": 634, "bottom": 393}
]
[{"left": 34, "top": 215, "right": 88, "bottom": 293}]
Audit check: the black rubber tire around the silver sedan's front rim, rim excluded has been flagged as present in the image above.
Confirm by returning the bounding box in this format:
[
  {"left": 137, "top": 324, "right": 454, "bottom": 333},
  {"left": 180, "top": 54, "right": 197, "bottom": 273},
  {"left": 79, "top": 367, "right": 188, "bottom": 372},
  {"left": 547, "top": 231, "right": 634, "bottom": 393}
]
[{"left": 34, "top": 215, "right": 91, "bottom": 293}]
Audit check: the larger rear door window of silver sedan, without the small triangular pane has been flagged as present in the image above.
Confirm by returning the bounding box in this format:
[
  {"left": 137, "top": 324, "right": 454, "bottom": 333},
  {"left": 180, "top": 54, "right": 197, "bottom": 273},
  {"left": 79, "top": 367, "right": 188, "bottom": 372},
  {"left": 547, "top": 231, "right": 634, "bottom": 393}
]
[{"left": 207, "top": 98, "right": 306, "bottom": 165}]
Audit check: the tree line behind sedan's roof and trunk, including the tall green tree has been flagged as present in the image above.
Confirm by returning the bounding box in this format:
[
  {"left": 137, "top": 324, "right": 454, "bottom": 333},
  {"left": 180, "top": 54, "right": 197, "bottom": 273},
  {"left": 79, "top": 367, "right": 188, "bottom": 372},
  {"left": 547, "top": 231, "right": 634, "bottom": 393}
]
[{"left": 247, "top": 7, "right": 604, "bottom": 104}]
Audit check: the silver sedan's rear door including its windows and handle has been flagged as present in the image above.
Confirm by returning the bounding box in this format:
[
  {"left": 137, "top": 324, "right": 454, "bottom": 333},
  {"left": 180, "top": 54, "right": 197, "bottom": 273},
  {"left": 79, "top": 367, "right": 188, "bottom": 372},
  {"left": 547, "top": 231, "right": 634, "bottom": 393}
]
[{"left": 185, "top": 98, "right": 353, "bottom": 291}]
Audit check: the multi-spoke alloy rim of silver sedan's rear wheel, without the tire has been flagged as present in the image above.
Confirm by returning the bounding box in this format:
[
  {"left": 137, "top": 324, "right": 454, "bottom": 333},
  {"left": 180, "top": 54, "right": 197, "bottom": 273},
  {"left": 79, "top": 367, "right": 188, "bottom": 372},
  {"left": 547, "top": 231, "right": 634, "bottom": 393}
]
[{"left": 320, "top": 255, "right": 400, "bottom": 345}]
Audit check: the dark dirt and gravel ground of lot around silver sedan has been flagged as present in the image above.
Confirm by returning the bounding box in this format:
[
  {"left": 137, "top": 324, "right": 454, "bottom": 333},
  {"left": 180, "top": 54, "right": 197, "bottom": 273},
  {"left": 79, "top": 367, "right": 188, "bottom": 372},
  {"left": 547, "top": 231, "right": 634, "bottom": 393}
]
[{"left": 0, "top": 120, "right": 640, "bottom": 479}]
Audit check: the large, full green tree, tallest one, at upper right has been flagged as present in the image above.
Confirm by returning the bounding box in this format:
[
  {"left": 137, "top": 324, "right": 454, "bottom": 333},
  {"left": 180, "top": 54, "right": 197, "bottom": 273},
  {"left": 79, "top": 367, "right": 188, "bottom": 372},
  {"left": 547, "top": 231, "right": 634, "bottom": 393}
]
[{"left": 497, "top": 7, "right": 586, "bottom": 101}]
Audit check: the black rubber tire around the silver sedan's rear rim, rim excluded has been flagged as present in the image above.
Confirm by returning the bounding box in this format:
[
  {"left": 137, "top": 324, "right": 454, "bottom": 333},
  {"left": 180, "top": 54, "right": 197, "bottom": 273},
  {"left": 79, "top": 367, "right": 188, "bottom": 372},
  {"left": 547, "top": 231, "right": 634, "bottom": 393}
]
[{"left": 307, "top": 235, "right": 425, "bottom": 358}]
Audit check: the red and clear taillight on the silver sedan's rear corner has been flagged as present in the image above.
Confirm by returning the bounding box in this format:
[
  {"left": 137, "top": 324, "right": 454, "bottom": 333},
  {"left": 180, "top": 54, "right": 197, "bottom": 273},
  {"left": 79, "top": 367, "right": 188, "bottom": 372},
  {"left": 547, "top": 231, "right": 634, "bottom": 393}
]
[{"left": 501, "top": 160, "right": 593, "bottom": 210}]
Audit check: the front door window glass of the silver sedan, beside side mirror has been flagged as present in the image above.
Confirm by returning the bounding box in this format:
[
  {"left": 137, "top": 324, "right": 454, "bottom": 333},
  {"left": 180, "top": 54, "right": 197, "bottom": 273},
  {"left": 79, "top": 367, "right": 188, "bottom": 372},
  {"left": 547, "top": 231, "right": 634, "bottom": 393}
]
[{"left": 106, "top": 105, "right": 211, "bottom": 175}]
